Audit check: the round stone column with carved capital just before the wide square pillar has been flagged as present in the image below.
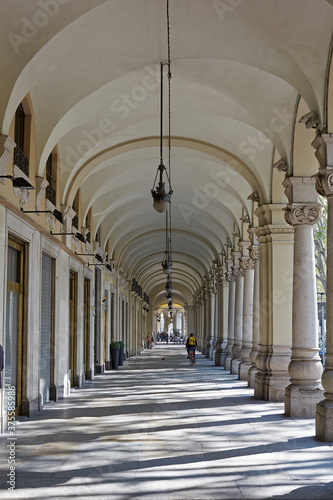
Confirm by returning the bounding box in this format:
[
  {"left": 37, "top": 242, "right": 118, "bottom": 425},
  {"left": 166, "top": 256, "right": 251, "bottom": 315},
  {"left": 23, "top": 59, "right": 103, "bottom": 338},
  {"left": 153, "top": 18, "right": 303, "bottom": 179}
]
[{"left": 283, "top": 177, "right": 323, "bottom": 417}]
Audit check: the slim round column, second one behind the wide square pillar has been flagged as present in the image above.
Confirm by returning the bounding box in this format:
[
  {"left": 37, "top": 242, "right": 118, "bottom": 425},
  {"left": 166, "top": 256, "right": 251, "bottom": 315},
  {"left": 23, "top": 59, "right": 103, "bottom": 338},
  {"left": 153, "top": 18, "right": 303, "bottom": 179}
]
[{"left": 239, "top": 257, "right": 254, "bottom": 380}]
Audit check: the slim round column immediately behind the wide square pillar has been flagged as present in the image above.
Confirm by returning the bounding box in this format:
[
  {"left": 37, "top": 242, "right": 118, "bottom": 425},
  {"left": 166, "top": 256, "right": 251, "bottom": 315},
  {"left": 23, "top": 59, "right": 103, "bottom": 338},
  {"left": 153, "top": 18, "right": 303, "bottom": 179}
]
[{"left": 248, "top": 246, "right": 259, "bottom": 387}]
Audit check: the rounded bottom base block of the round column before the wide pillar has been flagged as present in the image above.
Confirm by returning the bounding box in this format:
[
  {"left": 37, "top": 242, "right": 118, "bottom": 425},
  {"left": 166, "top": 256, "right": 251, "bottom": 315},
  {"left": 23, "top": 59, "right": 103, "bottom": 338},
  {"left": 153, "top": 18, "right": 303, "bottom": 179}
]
[{"left": 284, "top": 384, "right": 324, "bottom": 418}]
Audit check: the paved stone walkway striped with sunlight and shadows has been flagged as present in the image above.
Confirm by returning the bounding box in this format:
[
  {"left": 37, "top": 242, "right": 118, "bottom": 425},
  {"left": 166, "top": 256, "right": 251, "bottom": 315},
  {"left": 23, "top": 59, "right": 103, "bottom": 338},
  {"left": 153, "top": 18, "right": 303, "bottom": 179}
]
[{"left": 0, "top": 345, "right": 333, "bottom": 500}]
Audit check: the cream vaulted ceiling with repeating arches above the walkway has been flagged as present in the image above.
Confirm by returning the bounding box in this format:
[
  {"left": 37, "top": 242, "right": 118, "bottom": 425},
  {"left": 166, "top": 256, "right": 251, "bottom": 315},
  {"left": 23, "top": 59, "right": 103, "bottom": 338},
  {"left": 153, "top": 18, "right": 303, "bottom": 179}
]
[{"left": 0, "top": 0, "right": 333, "bottom": 302}]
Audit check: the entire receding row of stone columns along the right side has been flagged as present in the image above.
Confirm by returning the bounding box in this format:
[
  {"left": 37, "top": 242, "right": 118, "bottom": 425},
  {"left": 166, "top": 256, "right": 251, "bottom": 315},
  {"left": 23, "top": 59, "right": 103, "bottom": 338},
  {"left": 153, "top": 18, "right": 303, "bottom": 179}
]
[{"left": 194, "top": 138, "right": 333, "bottom": 441}]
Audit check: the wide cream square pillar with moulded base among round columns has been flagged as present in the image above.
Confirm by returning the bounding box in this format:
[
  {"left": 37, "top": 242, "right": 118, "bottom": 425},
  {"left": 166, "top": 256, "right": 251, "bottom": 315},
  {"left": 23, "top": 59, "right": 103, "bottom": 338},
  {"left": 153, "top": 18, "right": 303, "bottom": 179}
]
[{"left": 254, "top": 204, "right": 294, "bottom": 401}]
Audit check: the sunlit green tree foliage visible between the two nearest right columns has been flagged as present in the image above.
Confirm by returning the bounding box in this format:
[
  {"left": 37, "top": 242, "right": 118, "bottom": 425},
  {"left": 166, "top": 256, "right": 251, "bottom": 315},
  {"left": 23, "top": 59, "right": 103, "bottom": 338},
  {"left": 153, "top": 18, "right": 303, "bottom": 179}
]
[{"left": 314, "top": 196, "right": 327, "bottom": 294}]
